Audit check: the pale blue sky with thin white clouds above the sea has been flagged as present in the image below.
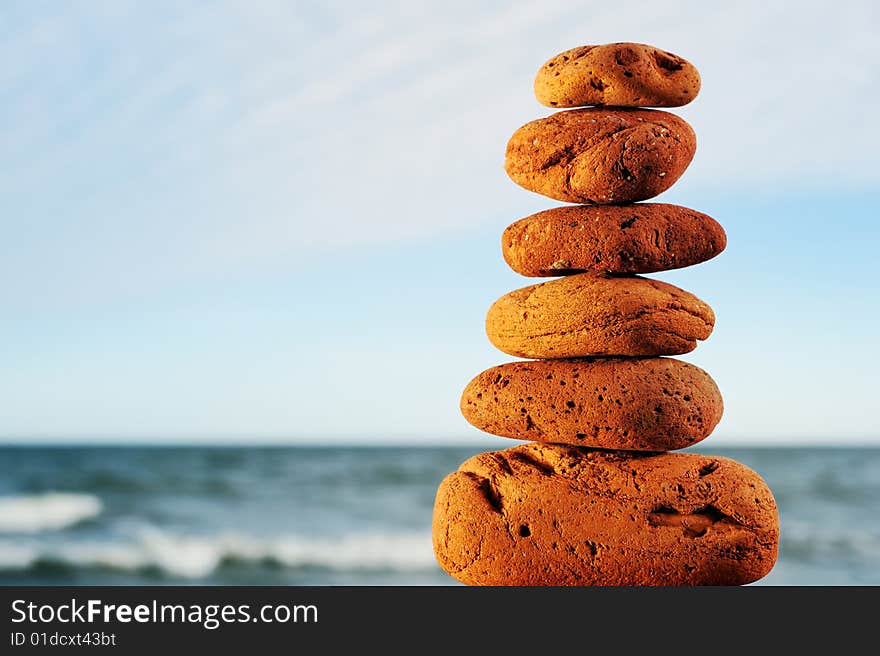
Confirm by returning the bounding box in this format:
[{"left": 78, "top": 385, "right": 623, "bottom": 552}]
[{"left": 0, "top": 0, "right": 880, "bottom": 448}]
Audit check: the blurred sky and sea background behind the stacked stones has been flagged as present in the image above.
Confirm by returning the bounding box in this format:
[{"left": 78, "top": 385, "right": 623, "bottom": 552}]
[{"left": 0, "top": 0, "right": 880, "bottom": 585}]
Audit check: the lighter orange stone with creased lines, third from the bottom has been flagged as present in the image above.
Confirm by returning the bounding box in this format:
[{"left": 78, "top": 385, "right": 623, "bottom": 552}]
[{"left": 486, "top": 273, "right": 715, "bottom": 358}]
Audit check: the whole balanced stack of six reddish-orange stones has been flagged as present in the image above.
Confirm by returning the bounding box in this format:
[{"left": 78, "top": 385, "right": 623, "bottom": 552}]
[{"left": 433, "top": 43, "right": 779, "bottom": 585}]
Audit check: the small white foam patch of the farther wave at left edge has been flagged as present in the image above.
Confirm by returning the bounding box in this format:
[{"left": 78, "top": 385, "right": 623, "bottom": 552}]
[{"left": 0, "top": 492, "right": 102, "bottom": 533}]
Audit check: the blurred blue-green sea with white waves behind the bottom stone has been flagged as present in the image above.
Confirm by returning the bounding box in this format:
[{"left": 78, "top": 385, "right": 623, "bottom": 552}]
[{"left": 0, "top": 447, "right": 880, "bottom": 585}]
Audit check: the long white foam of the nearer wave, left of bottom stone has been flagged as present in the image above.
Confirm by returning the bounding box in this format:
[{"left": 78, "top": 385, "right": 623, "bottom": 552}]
[{"left": 0, "top": 527, "right": 436, "bottom": 579}]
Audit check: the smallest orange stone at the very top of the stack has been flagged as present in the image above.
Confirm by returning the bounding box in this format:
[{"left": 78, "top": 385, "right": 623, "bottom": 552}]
[{"left": 535, "top": 43, "right": 700, "bottom": 107}]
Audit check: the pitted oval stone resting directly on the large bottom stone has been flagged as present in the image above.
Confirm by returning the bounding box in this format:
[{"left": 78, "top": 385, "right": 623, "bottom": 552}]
[{"left": 461, "top": 358, "right": 724, "bottom": 451}]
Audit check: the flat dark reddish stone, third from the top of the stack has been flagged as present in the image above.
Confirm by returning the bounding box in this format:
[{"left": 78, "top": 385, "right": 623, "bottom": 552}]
[{"left": 501, "top": 203, "right": 727, "bottom": 276}]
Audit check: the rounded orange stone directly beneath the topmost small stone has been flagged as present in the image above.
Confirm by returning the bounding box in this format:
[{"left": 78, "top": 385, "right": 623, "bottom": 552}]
[{"left": 504, "top": 108, "right": 697, "bottom": 205}]
